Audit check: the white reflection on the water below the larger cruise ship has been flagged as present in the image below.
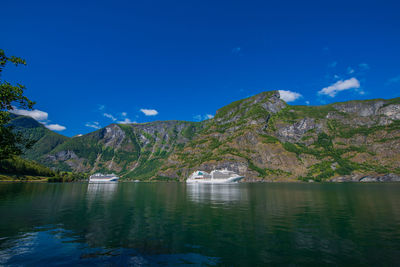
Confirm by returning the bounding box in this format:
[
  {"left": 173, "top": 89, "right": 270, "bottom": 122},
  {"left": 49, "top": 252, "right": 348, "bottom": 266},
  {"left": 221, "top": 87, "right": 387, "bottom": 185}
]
[{"left": 186, "top": 183, "right": 247, "bottom": 204}]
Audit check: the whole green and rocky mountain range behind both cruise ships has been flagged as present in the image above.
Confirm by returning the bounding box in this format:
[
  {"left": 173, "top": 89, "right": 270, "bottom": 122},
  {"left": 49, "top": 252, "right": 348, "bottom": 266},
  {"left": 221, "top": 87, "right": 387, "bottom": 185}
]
[{"left": 13, "top": 91, "right": 400, "bottom": 181}]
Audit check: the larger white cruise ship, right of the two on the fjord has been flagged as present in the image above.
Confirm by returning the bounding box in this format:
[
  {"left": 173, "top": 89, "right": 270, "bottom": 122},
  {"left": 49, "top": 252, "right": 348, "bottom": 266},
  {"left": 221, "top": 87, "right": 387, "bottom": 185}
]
[{"left": 186, "top": 169, "right": 244, "bottom": 184}]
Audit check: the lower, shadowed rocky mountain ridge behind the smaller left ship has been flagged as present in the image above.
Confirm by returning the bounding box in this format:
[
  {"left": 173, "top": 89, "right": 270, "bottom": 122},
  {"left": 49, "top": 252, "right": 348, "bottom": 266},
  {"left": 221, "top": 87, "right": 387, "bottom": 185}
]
[{"left": 36, "top": 121, "right": 201, "bottom": 179}]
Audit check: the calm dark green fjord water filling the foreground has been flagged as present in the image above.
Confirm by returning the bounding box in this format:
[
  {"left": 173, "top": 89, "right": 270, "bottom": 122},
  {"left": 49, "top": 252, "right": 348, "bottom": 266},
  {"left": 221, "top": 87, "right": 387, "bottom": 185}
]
[{"left": 0, "top": 183, "right": 400, "bottom": 266}]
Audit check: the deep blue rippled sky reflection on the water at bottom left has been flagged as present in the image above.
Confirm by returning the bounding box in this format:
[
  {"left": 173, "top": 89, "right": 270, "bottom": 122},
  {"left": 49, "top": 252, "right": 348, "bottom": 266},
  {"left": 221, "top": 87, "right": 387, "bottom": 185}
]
[{"left": 0, "top": 228, "right": 219, "bottom": 266}]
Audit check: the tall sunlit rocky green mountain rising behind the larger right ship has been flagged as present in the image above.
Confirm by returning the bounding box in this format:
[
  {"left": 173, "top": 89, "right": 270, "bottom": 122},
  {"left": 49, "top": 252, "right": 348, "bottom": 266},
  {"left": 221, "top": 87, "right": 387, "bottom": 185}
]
[{"left": 159, "top": 92, "right": 400, "bottom": 181}]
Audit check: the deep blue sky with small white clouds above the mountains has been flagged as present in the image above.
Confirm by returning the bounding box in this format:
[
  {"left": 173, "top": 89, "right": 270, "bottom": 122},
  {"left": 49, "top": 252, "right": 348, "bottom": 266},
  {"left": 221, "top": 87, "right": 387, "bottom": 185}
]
[{"left": 0, "top": 0, "right": 400, "bottom": 136}]
